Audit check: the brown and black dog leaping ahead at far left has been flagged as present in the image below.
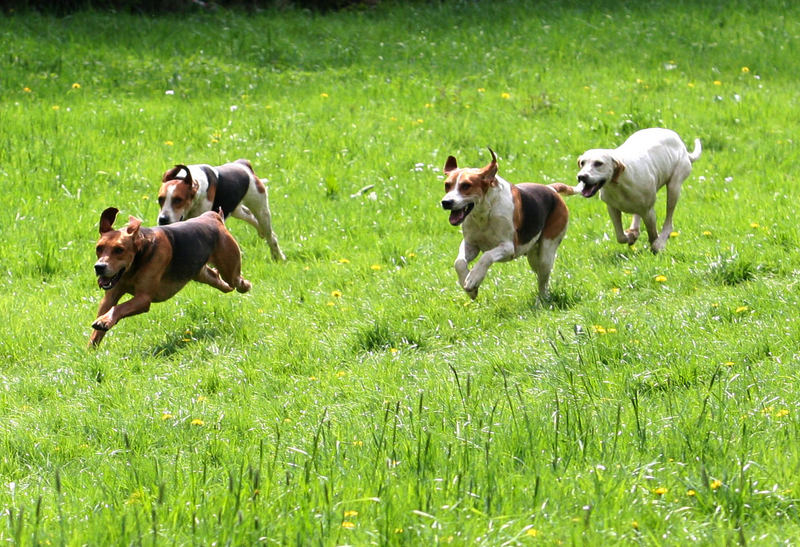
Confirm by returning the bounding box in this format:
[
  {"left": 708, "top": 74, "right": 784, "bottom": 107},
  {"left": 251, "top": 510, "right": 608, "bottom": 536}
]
[{"left": 89, "top": 207, "right": 251, "bottom": 346}]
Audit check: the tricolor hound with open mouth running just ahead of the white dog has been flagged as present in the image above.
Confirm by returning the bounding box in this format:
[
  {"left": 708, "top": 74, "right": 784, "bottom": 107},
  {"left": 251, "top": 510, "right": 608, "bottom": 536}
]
[{"left": 442, "top": 148, "right": 569, "bottom": 300}]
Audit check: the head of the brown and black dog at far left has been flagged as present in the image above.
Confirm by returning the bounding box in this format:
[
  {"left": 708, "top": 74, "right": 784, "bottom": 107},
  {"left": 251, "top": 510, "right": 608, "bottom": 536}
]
[{"left": 94, "top": 211, "right": 142, "bottom": 291}]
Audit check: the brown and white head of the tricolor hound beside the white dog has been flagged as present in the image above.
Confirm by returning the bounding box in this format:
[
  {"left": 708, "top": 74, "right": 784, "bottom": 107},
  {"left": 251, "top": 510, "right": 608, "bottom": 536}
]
[{"left": 442, "top": 153, "right": 497, "bottom": 226}]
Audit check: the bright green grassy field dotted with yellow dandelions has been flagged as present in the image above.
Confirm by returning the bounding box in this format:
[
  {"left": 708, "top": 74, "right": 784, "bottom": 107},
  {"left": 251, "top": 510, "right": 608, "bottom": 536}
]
[{"left": 0, "top": 0, "right": 800, "bottom": 545}]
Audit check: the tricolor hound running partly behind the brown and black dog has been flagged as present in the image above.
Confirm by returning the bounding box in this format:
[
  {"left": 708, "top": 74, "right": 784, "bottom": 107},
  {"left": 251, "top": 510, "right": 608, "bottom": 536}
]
[{"left": 158, "top": 159, "right": 286, "bottom": 261}]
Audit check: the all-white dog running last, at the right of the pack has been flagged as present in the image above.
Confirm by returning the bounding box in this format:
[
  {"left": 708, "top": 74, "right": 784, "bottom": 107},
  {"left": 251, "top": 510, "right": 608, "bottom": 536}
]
[{"left": 576, "top": 128, "right": 702, "bottom": 253}]
